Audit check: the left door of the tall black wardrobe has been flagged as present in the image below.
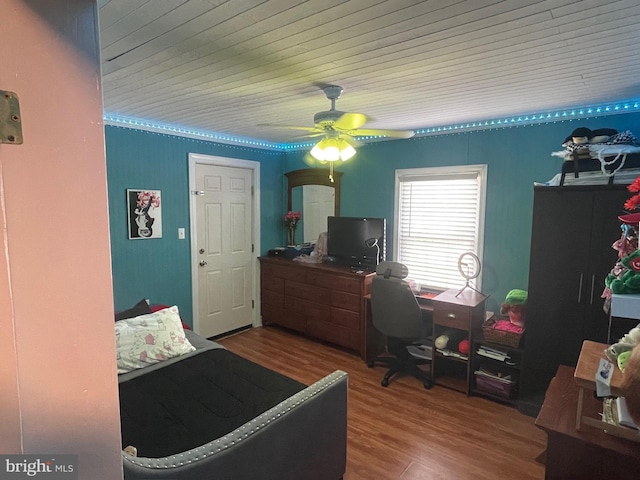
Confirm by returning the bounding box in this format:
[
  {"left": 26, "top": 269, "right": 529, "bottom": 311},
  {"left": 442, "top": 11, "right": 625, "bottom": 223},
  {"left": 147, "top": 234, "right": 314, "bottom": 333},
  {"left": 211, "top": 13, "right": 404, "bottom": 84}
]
[{"left": 519, "top": 187, "right": 594, "bottom": 416}]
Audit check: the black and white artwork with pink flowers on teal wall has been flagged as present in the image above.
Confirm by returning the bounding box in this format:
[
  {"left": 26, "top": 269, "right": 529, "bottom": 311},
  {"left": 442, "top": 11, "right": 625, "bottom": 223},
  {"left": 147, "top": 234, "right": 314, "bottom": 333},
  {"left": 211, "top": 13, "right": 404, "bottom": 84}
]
[{"left": 127, "top": 189, "right": 162, "bottom": 240}]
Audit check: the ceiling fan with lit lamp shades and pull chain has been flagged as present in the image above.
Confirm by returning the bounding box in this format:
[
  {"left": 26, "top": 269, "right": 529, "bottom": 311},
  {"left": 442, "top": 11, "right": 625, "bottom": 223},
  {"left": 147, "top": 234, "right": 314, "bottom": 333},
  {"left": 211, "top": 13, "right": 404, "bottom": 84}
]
[{"left": 262, "top": 85, "right": 414, "bottom": 177}]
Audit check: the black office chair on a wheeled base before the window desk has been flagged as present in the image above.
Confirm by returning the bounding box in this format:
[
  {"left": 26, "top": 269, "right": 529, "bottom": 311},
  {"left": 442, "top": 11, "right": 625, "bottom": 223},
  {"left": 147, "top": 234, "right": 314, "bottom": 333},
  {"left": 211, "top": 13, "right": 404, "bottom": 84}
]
[{"left": 368, "top": 262, "right": 433, "bottom": 389}]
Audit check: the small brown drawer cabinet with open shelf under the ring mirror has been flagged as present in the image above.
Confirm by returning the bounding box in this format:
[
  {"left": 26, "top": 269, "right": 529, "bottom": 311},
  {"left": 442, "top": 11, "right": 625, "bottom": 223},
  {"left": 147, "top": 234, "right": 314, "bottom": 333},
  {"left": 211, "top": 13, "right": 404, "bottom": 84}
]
[{"left": 431, "top": 289, "right": 487, "bottom": 395}]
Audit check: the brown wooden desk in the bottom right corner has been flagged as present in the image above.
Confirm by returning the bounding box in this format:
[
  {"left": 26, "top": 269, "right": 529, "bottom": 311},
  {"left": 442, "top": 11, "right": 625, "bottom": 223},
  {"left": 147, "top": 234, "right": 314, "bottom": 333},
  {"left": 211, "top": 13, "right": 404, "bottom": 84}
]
[{"left": 535, "top": 365, "right": 640, "bottom": 480}]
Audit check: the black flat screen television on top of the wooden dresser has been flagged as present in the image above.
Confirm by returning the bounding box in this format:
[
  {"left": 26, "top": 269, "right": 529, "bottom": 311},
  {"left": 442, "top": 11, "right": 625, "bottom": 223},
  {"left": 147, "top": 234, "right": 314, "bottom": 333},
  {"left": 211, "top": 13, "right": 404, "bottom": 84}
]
[{"left": 327, "top": 217, "right": 387, "bottom": 270}]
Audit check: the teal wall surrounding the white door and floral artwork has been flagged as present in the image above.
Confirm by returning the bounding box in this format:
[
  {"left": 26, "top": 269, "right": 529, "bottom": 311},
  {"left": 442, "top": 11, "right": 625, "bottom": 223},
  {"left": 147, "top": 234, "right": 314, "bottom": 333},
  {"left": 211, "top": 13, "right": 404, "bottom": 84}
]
[{"left": 105, "top": 126, "right": 286, "bottom": 324}]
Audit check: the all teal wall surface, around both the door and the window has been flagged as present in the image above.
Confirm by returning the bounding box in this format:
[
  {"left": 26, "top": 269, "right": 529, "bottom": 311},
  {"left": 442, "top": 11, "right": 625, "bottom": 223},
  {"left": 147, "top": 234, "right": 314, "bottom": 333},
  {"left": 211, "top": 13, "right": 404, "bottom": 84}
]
[{"left": 105, "top": 114, "right": 640, "bottom": 323}]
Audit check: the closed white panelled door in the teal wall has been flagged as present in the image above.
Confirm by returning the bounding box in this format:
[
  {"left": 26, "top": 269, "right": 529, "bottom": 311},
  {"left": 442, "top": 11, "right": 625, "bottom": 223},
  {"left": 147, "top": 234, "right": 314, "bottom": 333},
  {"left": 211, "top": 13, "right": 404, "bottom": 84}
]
[{"left": 191, "top": 163, "right": 254, "bottom": 337}]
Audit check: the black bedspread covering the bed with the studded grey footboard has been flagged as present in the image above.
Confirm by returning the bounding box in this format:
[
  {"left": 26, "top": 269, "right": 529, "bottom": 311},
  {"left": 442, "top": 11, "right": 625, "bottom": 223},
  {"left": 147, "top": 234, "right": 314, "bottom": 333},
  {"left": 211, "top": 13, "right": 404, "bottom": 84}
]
[{"left": 119, "top": 349, "right": 306, "bottom": 458}]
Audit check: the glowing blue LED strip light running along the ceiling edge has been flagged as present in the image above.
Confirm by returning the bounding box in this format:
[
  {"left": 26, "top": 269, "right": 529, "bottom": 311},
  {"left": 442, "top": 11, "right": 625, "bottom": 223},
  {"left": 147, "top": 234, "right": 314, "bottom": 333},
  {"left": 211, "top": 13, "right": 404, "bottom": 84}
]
[{"left": 104, "top": 100, "right": 640, "bottom": 152}]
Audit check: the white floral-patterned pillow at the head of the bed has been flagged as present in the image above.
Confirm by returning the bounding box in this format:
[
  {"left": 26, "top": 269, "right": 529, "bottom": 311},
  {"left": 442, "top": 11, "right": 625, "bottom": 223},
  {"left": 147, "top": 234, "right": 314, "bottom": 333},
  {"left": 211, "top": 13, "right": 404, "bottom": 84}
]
[{"left": 116, "top": 305, "right": 195, "bottom": 373}]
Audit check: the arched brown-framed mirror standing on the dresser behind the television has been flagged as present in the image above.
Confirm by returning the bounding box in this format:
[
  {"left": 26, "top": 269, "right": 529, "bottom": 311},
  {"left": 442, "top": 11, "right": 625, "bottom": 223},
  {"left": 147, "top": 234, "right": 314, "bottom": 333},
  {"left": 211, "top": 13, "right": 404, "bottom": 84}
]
[{"left": 285, "top": 168, "right": 342, "bottom": 243}]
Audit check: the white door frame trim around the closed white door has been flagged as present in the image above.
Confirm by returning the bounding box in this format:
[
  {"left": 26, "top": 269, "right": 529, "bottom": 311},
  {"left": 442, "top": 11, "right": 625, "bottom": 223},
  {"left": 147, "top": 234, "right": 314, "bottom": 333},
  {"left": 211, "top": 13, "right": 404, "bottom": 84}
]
[{"left": 189, "top": 153, "right": 260, "bottom": 332}]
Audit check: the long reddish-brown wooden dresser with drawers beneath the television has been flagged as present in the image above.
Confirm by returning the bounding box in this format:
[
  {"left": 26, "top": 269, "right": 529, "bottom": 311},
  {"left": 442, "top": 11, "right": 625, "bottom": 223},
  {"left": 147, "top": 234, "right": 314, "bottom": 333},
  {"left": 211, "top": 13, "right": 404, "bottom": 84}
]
[{"left": 260, "top": 257, "right": 380, "bottom": 361}]
